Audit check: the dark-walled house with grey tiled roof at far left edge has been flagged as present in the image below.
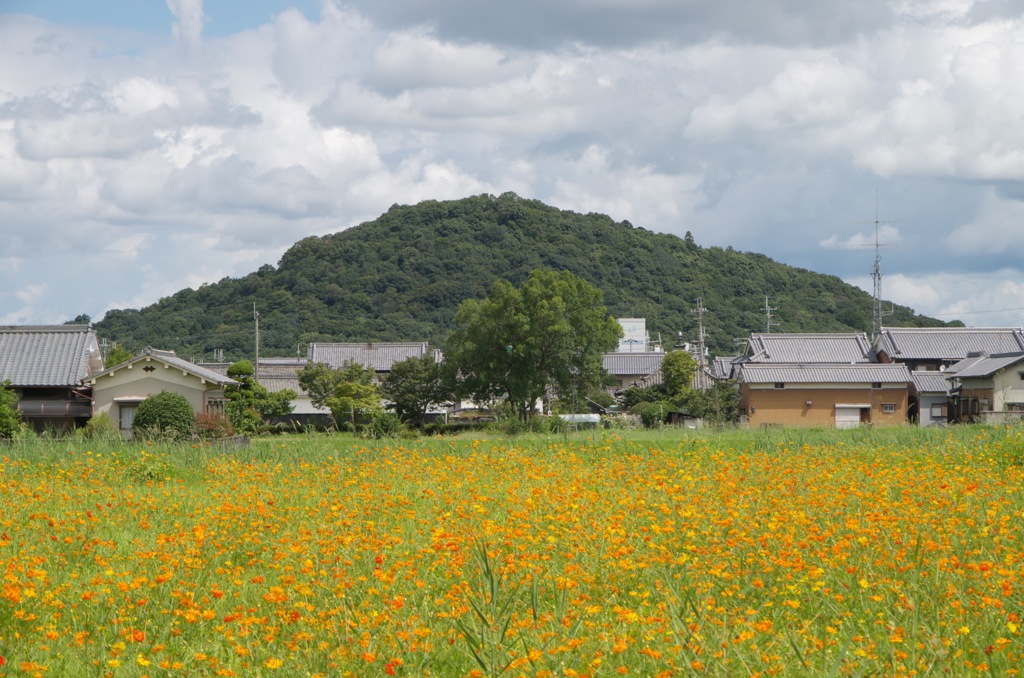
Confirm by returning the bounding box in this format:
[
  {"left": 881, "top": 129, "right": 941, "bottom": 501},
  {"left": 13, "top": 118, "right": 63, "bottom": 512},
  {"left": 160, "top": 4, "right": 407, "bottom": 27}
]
[{"left": 0, "top": 325, "right": 103, "bottom": 431}]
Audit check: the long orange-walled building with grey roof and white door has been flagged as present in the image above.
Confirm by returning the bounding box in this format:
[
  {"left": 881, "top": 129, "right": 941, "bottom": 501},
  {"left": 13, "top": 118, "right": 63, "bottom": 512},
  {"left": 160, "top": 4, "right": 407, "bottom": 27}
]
[{"left": 738, "top": 363, "right": 910, "bottom": 428}]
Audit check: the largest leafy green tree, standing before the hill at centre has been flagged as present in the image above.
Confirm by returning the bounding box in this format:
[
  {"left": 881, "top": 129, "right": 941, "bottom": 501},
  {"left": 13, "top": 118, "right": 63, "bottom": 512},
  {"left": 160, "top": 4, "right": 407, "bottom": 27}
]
[{"left": 447, "top": 269, "right": 622, "bottom": 421}]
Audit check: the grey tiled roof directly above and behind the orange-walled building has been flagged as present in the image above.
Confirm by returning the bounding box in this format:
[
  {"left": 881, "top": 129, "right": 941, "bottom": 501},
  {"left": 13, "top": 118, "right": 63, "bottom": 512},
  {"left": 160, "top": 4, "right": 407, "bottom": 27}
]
[{"left": 740, "top": 332, "right": 872, "bottom": 364}]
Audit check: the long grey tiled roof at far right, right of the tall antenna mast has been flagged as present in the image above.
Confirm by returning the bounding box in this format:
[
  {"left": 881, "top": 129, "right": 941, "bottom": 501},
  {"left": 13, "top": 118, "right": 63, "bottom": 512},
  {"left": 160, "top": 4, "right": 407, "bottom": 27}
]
[{"left": 874, "top": 328, "right": 1024, "bottom": 361}]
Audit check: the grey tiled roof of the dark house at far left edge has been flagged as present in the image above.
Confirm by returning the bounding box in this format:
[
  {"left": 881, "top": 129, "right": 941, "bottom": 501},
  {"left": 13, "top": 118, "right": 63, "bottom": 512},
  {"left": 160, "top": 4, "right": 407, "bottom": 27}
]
[{"left": 0, "top": 325, "right": 102, "bottom": 386}]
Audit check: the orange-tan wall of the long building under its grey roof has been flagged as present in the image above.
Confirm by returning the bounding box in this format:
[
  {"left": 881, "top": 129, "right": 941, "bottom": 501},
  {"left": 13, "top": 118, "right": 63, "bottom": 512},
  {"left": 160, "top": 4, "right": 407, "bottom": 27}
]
[{"left": 739, "top": 384, "right": 908, "bottom": 428}]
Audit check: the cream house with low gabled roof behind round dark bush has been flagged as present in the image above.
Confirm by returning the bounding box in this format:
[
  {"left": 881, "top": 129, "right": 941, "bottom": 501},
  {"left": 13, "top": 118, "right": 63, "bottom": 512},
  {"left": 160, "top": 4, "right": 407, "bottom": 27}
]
[{"left": 85, "top": 348, "right": 238, "bottom": 429}]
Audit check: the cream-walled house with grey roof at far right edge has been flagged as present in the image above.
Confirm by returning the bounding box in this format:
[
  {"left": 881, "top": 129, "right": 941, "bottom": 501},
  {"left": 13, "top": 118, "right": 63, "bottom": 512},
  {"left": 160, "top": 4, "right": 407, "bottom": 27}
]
[{"left": 944, "top": 351, "right": 1024, "bottom": 422}]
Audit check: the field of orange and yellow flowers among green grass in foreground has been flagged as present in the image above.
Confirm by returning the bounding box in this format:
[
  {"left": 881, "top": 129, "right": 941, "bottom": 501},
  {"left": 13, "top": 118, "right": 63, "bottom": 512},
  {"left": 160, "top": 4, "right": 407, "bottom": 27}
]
[{"left": 0, "top": 427, "right": 1024, "bottom": 677}]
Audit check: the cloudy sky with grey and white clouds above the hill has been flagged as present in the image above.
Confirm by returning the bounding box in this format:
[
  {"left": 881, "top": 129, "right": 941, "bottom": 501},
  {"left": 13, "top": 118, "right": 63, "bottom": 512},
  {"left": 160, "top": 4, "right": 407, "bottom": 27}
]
[{"left": 0, "top": 0, "right": 1024, "bottom": 329}]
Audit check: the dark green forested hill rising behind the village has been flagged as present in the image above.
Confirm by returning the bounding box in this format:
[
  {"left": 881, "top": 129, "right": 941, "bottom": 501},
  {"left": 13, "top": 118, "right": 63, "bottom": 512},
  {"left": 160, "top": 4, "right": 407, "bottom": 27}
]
[{"left": 96, "top": 194, "right": 943, "bottom": 359}]
